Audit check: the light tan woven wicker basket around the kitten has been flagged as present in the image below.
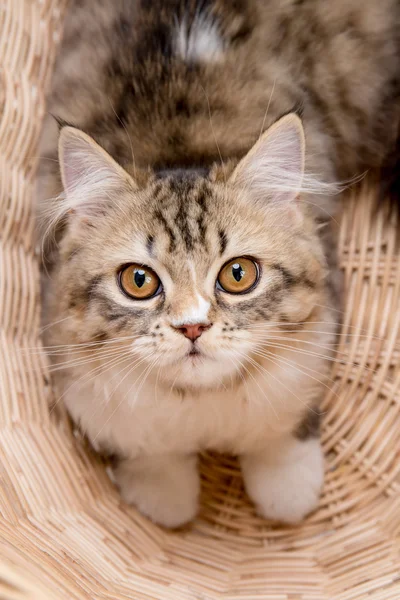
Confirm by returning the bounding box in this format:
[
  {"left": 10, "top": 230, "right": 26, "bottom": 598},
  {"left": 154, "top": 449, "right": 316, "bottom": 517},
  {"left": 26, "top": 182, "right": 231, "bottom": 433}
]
[{"left": 0, "top": 0, "right": 400, "bottom": 600}]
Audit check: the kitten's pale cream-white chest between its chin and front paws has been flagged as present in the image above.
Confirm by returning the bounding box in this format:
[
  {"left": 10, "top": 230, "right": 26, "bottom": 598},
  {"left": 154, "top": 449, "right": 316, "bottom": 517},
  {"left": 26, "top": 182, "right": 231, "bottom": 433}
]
[{"left": 62, "top": 358, "right": 304, "bottom": 456}]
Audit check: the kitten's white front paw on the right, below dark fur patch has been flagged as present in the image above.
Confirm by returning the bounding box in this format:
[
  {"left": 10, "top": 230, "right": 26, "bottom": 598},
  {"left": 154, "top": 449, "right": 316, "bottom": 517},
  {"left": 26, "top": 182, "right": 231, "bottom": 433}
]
[{"left": 241, "top": 438, "right": 324, "bottom": 524}]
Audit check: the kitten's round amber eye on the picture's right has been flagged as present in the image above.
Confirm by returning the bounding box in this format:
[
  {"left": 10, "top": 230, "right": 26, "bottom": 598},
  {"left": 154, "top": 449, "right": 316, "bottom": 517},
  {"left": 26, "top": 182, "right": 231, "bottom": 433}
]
[{"left": 217, "top": 257, "right": 260, "bottom": 294}]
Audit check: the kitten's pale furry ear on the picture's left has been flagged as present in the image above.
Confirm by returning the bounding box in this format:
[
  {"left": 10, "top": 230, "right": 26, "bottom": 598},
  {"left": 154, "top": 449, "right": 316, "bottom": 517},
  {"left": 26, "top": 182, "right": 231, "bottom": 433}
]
[{"left": 58, "top": 127, "right": 136, "bottom": 220}]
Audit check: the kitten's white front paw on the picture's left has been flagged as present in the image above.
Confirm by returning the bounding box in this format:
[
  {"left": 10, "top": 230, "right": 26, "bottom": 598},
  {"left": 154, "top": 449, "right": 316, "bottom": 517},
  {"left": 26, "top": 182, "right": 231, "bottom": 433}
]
[{"left": 114, "top": 456, "right": 200, "bottom": 528}]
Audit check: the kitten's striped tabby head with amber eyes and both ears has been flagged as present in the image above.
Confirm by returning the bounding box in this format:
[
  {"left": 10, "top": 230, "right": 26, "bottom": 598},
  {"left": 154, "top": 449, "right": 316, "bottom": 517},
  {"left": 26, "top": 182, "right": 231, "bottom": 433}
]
[{"left": 52, "top": 115, "right": 332, "bottom": 388}]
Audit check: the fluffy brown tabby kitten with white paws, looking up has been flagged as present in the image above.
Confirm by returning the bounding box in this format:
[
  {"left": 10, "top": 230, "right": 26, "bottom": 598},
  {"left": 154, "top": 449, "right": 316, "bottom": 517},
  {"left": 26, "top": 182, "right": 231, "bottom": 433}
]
[{"left": 38, "top": 0, "right": 400, "bottom": 527}]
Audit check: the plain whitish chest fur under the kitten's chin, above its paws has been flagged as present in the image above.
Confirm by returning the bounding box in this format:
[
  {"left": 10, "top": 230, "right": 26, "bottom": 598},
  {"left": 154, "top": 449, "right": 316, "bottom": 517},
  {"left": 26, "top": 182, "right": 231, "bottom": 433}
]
[{"left": 65, "top": 340, "right": 326, "bottom": 457}]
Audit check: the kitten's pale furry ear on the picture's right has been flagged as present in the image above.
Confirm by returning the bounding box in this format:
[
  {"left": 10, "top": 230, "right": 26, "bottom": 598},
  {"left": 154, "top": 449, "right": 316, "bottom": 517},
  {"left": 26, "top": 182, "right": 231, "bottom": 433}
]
[{"left": 230, "top": 113, "right": 305, "bottom": 206}]
